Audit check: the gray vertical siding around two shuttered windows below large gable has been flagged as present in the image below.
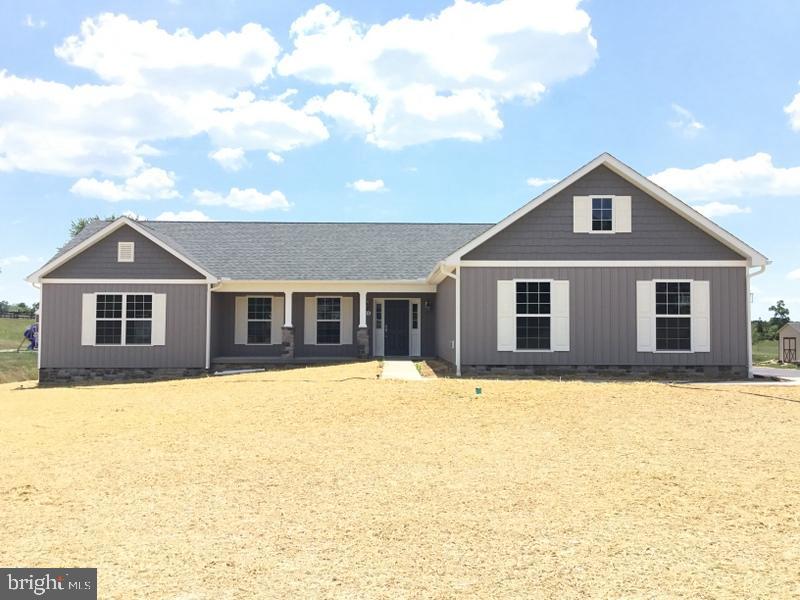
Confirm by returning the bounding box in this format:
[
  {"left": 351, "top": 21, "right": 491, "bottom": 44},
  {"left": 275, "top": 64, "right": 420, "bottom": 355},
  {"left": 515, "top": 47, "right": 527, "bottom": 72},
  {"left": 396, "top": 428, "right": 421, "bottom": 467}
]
[{"left": 461, "top": 267, "right": 747, "bottom": 366}]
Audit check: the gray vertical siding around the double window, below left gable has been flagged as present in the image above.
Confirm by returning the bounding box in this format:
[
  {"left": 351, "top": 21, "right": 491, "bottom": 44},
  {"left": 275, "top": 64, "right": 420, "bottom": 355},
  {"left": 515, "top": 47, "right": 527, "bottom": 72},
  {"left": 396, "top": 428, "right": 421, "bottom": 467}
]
[{"left": 41, "top": 283, "right": 208, "bottom": 369}]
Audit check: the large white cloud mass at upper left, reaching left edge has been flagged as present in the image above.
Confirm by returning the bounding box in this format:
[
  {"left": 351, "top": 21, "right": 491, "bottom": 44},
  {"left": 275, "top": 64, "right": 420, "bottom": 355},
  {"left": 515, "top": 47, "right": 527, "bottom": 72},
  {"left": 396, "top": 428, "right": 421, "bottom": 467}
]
[{"left": 0, "top": 15, "right": 329, "bottom": 176}]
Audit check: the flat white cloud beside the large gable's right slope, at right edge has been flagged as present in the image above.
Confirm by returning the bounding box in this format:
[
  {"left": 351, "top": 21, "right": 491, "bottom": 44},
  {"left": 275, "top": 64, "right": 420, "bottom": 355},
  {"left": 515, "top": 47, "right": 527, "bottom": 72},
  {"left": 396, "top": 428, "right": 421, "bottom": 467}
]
[{"left": 650, "top": 152, "right": 800, "bottom": 201}]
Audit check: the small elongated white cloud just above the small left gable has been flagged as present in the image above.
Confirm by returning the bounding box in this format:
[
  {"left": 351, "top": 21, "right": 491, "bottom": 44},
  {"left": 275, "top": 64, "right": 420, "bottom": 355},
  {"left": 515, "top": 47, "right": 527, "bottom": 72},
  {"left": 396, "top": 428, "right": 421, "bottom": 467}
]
[{"left": 70, "top": 167, "right": 180, "bottom": 202}]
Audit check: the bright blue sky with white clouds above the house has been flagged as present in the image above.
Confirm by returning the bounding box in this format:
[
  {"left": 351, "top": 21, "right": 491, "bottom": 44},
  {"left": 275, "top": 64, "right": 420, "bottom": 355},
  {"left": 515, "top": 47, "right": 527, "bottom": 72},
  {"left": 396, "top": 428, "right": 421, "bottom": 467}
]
[{"left": 0, "top": 0, "right": 800, "bottom": 317}]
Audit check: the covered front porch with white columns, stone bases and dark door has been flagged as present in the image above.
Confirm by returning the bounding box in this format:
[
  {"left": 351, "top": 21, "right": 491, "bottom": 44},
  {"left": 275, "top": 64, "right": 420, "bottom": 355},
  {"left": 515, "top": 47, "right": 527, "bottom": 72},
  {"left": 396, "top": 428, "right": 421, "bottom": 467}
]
[{"left": 209, "top": 281, "right": 436, "bottom": 367}]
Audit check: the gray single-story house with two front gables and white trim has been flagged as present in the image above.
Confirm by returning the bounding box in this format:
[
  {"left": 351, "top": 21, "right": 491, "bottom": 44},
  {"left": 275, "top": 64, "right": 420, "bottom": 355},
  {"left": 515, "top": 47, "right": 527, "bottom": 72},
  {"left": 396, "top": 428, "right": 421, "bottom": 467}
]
[{"left": 28, "top": 154, "right": 769, "bottom": 382}]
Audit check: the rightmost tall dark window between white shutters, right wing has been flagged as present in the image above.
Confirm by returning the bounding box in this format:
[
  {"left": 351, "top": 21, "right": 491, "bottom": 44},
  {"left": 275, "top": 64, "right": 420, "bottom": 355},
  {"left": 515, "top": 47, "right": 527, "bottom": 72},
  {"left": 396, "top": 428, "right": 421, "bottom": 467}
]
[{"left": 656, "top": 281, "right": 692, "bottom": 352}]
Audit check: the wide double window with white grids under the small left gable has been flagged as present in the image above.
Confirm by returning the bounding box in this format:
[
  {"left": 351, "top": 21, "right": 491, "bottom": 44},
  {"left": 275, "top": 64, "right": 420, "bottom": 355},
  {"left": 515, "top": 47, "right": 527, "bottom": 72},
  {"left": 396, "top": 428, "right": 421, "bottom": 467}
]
[{"left": 95, "top": 294, "right": 153, "bottom": 346}]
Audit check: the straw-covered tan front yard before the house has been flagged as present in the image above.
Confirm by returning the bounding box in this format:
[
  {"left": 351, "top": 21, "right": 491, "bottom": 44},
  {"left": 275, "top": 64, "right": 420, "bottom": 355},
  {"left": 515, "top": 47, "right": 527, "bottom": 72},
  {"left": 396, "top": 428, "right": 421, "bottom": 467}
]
[{"left": 0, "top": 363, "right": 800, "bottom": 600}]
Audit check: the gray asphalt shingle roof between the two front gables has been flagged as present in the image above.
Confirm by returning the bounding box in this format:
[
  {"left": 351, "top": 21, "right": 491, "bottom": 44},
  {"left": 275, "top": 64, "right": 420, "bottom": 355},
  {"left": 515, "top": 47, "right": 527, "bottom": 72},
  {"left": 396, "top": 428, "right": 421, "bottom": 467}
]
[{"left": 51, "top": 221, "right": 492, "bottom": 280}]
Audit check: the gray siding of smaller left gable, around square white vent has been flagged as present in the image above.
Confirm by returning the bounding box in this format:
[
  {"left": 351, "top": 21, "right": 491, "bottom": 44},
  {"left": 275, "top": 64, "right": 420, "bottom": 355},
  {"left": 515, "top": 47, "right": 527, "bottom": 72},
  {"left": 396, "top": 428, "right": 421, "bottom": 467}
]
[{"left": 45, "top": 226, "right": 204, "bottom": 279}]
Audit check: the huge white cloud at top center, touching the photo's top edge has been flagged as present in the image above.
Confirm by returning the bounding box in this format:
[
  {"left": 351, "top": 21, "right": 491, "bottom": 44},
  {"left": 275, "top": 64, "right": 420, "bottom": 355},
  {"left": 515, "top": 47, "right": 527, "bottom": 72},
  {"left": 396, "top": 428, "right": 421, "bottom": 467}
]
[{"left": 278, "top": 0, "right": 597, "bottom": 148}]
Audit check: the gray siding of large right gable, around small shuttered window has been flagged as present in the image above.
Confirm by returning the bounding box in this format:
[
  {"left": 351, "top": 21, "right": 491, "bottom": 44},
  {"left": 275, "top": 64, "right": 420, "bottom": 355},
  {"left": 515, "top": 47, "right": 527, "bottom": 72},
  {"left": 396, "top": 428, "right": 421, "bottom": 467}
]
[{"left": 464, "top": 166, "right": 743, "bottom": 260}]
